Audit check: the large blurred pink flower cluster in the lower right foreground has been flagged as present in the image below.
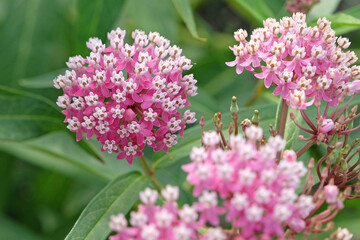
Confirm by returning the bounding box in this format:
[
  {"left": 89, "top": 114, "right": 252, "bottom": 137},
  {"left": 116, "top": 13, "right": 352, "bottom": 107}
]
[{"left": 183, "top": 125, "right": 315, "bottom": 239}]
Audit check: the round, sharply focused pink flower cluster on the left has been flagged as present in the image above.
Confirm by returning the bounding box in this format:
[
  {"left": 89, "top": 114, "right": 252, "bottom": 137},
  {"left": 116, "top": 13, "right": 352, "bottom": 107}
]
[{"left": 54, "top": 28, "right": 197, "bottom": 164}]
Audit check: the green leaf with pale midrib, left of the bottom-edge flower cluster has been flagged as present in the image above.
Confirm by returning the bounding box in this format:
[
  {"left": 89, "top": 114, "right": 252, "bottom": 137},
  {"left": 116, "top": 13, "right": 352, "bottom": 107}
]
[{"left": 65, "top": 172, "right": 150, "bottom": 240}]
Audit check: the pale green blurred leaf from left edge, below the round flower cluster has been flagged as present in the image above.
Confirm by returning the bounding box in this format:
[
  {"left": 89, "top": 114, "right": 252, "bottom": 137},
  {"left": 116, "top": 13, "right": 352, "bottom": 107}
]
[{"left": 0, "top": 132, "right": 121, "bottom": 184}]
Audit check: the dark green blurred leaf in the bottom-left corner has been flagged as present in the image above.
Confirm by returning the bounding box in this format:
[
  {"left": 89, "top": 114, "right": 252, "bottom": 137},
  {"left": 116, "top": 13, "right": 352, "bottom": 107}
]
[{"left": 0, "top": 216, "right": 44, "bottom": 240}]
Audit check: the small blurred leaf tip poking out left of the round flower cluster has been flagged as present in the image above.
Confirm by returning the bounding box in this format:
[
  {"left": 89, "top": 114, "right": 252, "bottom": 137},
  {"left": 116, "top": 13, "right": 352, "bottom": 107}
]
[{"left": 19, "top": 68, "right": 67, "bottom": 88}]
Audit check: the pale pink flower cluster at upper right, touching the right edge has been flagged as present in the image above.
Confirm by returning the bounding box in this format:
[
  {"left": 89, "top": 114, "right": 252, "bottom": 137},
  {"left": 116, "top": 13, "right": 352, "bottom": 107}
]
[{"left": 227, "top": 13, "right": 360, "bottom": 109}]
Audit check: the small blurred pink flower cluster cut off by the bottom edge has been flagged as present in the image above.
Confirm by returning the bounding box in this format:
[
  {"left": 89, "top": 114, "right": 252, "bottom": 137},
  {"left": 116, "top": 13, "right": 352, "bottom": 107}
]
[{"left": 109, "top": 185, "right": 222, "bottom": 240}]
